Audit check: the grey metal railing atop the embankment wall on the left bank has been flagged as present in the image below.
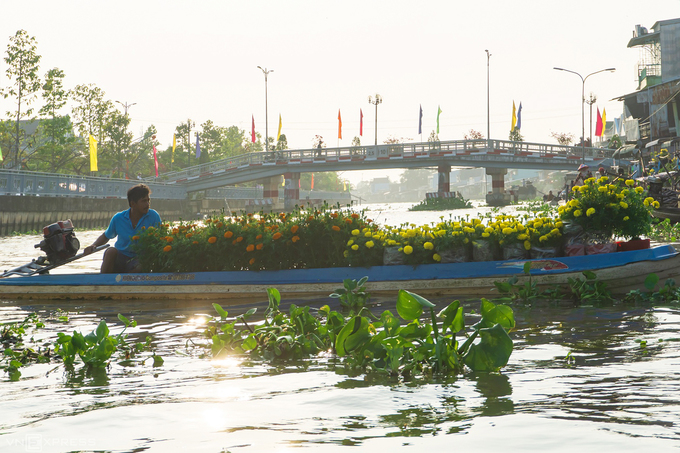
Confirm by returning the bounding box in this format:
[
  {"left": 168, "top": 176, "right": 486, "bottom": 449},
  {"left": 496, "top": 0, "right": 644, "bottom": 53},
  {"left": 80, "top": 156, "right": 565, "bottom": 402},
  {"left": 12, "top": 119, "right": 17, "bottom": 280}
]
[{"left": 0, "top": 170, "right": 186, "bottom": 200}]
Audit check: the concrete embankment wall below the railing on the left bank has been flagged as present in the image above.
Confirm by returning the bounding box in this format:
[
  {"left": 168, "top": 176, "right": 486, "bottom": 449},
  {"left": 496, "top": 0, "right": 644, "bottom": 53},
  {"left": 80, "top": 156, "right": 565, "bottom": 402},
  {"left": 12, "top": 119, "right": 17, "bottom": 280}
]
[{"left": 0, "top": 195, "right": 244, "bottom": 236}]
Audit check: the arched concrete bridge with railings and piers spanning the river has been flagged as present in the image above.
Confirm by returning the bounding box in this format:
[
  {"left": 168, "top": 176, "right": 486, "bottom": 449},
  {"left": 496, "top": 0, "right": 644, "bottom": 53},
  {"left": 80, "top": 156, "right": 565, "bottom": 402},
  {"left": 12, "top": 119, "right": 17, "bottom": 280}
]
[{"left": 147, "top": 140, "right": 624, "bottom": 207}]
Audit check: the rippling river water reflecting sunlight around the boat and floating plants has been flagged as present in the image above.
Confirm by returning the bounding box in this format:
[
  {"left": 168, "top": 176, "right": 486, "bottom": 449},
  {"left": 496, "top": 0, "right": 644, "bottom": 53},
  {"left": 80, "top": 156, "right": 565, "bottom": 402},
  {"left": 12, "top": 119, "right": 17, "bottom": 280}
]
[{"left": 0, "top": 204, "right": 680, "bottom": 453}]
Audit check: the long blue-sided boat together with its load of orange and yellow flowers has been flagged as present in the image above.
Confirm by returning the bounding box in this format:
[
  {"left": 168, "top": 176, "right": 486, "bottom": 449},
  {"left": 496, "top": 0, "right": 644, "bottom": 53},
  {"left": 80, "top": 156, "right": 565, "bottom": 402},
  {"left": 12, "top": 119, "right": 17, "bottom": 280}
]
[{"left": 0, "top": 177, "right": 680, "bottom": 299}]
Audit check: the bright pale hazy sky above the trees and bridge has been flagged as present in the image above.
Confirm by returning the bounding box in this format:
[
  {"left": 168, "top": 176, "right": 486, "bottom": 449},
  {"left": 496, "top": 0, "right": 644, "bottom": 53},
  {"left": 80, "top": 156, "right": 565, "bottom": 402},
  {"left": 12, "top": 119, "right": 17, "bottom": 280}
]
[{"left": 0, "top": 0, "right": 680, "bottom": 182}]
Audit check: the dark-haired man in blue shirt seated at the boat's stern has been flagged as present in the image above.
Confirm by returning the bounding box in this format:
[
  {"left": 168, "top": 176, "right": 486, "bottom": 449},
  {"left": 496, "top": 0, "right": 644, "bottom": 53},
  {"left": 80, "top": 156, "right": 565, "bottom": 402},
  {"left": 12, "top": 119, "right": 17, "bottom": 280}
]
[{"left": 83, "top": 184, "right": 161, "bottom": 274}]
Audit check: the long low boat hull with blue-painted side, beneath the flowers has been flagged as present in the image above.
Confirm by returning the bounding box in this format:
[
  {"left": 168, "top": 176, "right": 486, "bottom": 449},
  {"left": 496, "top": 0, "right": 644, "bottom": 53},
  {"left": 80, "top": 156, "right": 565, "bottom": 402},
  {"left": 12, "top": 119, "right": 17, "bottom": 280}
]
[{"left": 0, "top": 245, "right": 680, "bottom": 300}]
